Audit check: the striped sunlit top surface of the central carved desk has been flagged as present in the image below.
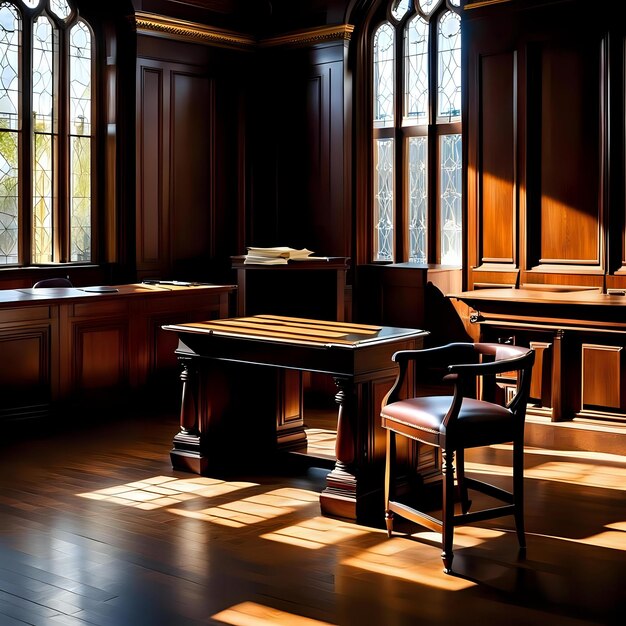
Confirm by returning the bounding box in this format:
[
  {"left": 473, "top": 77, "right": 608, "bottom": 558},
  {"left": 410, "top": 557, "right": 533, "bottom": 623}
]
[{"left": 163, "top": 315, "right": 428, "bottom": 348}]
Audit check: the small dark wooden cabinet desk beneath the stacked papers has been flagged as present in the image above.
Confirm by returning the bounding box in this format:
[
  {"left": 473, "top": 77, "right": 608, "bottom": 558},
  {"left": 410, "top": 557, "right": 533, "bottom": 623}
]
[{"left": 231, "top": 256, "right": 350, "bottom": 321}]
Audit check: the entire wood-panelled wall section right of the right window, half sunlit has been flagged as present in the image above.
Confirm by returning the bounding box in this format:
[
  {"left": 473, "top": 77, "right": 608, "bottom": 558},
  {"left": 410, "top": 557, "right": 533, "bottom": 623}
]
[{"left": 462, "top": 0, "right": 612, "bottom": 288}]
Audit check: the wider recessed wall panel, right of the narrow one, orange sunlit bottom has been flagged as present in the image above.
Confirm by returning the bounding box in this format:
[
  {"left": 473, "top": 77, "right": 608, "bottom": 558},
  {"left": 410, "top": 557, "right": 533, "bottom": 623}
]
[{"left": 529, "top": 41, "right": 602, "bottom": 267}]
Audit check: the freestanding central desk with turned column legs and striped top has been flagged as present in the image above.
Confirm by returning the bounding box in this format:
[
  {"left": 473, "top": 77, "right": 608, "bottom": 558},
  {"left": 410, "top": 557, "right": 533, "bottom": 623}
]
[{"left": 164, "top": 315, "right": 428, "bottom": 520}]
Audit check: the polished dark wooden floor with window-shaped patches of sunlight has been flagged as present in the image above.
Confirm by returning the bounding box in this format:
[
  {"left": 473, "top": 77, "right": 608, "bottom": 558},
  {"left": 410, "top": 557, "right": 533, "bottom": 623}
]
[{"left": 0, "top": 404, "right": 626, "bottom": 626}]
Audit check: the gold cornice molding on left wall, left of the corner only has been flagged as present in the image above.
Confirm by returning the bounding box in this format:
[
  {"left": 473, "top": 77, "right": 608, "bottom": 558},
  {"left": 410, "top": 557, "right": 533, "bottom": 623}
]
[{"left": 134, "top": 12, "right": 257, "bottom": 48}]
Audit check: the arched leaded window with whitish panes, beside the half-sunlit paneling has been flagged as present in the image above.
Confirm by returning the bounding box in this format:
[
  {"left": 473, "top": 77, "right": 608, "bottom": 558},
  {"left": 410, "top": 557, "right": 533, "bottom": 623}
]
[{"left": 371, "top": 0, "right": 462, "bottom": 265}]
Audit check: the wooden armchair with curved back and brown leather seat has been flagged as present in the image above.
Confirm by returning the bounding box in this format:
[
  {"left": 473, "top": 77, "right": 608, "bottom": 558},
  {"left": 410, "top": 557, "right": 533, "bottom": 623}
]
[{"left": 381, "top": 342, "right": 535, "bottom": 573}]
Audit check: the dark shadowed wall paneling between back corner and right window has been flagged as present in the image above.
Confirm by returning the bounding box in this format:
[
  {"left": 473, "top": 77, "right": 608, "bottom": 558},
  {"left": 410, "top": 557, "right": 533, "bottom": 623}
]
[{"left": 251, "top": 42, "right": 352, "bottom": 256}]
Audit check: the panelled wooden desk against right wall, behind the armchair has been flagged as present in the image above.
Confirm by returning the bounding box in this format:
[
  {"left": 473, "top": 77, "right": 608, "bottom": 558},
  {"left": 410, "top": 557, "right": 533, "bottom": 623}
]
[{"left": 450, "top": 285, "right": 626, "bottom": 422}]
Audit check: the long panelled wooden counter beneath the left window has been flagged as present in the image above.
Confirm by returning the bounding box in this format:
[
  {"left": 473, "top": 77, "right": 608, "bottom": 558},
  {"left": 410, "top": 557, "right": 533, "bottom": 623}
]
[{"left": 0, "top": 284, "right": 236, "bottom": 422}]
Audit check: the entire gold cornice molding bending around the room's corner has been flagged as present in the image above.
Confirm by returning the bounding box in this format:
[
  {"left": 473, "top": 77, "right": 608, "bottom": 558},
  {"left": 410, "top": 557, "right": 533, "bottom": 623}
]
[{"left": 131, "top": 11, "right": 354, "bottom": 48}]
